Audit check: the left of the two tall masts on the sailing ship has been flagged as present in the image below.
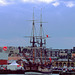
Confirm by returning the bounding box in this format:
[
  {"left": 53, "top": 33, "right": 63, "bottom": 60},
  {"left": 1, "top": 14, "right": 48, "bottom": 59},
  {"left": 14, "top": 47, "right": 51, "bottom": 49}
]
[{"left": 25, "top": 8, "right": 39, "bottom": 63}]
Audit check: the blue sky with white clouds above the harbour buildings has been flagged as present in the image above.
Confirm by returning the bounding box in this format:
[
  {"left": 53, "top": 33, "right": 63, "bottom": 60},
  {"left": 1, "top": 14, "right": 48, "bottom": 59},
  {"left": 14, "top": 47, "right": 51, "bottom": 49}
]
[{"left": 0, "top": 0, "right": 75, "bottom": 49}]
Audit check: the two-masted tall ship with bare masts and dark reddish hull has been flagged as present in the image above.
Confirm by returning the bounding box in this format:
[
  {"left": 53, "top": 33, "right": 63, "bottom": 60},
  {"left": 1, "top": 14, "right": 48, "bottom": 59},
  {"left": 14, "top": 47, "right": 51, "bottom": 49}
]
[{"left": 23, "top": 9, "right": 51, "bottom": 72}]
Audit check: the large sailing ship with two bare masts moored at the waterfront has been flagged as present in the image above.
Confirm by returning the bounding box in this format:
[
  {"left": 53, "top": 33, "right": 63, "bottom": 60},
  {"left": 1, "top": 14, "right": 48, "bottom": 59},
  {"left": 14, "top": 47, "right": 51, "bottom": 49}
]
[{"left": 22, "top": 10, "right": 52, "bottom": 73}]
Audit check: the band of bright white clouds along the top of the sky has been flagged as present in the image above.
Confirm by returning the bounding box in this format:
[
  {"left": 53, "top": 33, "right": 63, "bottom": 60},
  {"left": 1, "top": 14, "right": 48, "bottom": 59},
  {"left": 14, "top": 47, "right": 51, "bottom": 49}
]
[{"left": 0, "top": 0, "right": 75, "bottom": 8}]
